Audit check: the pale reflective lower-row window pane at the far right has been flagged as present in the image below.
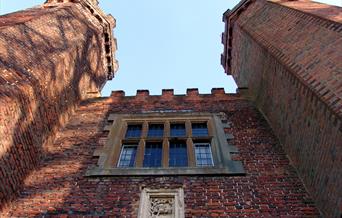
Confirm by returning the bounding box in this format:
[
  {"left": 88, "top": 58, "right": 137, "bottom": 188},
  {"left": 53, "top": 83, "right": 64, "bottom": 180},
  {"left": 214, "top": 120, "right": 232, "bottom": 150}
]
[{"left": 195, "top": 143, "right": 214, "bottom": 167}]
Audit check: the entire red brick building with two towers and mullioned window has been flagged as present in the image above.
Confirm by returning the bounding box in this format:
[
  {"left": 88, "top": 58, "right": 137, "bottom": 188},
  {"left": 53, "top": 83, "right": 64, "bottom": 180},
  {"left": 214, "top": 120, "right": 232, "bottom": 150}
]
[{"left": 0, "top": 0, "right": 342, "bottom": 217}]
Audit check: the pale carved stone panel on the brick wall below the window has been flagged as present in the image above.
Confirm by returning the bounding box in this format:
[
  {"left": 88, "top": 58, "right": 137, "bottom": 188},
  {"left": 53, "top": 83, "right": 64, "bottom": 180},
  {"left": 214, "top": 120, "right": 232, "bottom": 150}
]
[{"left": 138, "top": 188, "right": 184, "bottom": 218}]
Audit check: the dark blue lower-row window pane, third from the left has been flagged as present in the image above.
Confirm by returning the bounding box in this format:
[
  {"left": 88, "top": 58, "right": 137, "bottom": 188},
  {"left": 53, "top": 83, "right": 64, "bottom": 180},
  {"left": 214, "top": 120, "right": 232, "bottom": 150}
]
[{"left": 169, "top": 142, "right": 188, "bottom": 167}]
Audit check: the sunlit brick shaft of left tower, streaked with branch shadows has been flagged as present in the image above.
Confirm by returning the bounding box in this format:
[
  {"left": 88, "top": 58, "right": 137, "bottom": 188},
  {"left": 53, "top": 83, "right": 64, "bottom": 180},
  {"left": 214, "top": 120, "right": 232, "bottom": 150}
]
[{"left": 0, "top": 3, "right": 117, "bottom": 208}]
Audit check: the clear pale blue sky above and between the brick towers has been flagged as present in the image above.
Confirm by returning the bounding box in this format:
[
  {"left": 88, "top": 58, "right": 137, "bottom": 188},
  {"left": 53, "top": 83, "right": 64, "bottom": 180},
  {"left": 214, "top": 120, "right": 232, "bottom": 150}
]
[{"left": 0, "top": 0, "right": 342, "bottom": 96}]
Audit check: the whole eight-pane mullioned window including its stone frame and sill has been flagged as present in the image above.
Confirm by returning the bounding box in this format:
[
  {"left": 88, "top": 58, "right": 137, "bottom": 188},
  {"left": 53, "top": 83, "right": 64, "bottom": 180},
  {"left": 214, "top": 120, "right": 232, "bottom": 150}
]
[{"left": 86, "top": 112, "right": 244, "bottom": 176}]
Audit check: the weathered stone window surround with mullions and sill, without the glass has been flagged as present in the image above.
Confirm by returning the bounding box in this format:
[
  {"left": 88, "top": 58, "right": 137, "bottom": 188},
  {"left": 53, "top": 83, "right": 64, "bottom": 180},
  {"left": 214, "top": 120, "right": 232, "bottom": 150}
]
[{"left": 86, "top": 112, "right": 245, "bottom": 176}]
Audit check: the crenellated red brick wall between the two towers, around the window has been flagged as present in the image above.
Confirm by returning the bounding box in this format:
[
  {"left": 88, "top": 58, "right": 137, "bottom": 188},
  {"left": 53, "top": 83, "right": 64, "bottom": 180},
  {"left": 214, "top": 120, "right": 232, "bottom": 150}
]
[{"left": 0, "top": 89, "right": 319, "bottom": 217}]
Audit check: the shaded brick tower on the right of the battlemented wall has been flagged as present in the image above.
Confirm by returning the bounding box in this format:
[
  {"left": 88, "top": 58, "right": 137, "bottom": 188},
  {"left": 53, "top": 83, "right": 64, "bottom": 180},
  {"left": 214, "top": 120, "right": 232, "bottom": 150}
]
[{"left": 222, "top": 1, "right": 342, "bottom": 217}]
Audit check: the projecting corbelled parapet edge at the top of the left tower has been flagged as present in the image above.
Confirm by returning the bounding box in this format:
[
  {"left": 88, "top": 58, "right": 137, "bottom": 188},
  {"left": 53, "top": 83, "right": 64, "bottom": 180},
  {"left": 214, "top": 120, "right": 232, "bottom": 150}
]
[{"left": 43, "top": 0, "right": 119, "bottom": 80}]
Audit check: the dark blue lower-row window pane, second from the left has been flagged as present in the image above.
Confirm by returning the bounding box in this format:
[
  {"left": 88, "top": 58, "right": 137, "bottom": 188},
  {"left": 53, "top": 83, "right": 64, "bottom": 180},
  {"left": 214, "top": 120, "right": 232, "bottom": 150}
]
[{"left": 143, "top": 142, "right": 163, "bottom": 167}]
